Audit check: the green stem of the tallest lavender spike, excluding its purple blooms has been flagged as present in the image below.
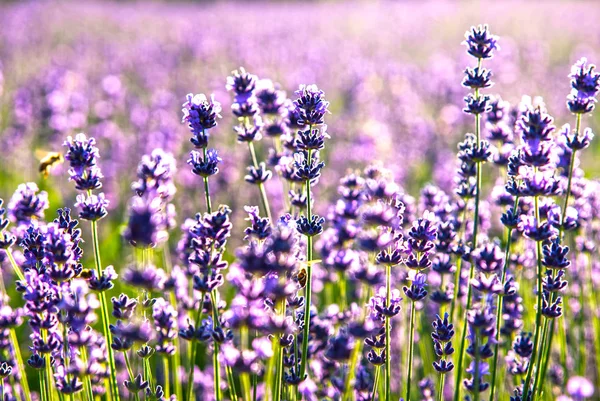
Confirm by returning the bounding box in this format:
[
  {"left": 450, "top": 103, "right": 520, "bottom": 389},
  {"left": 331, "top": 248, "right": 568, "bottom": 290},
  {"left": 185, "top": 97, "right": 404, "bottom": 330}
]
[{"left": 454, "top": 59, "right": 481, "bottom": 401}]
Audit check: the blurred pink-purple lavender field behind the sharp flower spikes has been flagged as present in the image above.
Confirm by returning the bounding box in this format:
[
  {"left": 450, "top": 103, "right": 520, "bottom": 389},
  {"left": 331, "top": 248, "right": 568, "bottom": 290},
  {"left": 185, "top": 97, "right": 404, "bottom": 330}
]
[{"left": 0, "top": 1, "right": 600, "bottom": 263}]
